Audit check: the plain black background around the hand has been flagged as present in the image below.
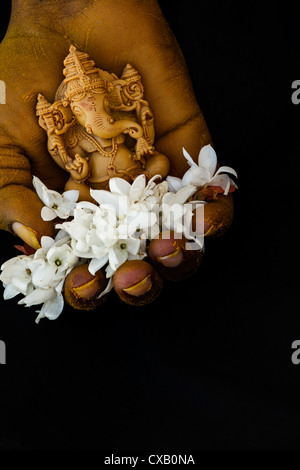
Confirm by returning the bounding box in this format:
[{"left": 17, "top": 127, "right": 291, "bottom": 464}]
[{"left": 0, "top": 0, "right": 300, "bottom": 455}]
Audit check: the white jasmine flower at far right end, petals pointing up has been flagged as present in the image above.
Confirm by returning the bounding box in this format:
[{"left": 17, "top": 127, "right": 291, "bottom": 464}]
[{"left": 167, "top": 145, "right": 237, "bottom": 196}]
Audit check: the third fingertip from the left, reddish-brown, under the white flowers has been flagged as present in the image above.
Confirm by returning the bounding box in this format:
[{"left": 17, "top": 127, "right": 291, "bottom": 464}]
[{"left": 148, "top": 231, "right": 202, "bottom": 281}]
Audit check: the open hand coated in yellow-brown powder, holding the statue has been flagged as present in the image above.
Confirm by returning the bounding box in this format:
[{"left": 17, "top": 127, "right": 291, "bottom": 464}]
[{"left": 0, "top": 0, "right": 232, "bottom": 310}]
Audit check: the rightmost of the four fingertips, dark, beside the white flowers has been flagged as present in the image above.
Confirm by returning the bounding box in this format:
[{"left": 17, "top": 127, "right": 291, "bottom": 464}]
[{"left": 192, "top": 195, "right": 233, "bottom": 237}]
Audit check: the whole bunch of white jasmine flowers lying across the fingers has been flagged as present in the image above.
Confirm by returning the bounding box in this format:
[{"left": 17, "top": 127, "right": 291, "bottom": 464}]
[{"left": 0, "top": 162, "right": 237, "bottom": 323}]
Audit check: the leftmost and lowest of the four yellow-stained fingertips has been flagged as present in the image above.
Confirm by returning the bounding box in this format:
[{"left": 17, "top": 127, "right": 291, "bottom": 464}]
[{"left": 64, "top": 264, "right": 107, "bottom": 310}]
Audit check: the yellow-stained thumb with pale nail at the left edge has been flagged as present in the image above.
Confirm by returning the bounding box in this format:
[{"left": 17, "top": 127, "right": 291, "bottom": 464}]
[{"left": 0, "top": 148, "right": 54, "bottom": 249}]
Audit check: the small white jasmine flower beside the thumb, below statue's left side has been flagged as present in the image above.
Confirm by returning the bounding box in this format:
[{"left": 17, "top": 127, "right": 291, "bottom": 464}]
[{"left": 33, "top": 176, "right": 79, "bottom": 220}]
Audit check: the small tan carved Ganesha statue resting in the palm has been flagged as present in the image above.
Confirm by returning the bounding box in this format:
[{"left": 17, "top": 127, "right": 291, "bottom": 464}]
[{"left": 36, "top": 46, "right": 170, "bottom": 200}]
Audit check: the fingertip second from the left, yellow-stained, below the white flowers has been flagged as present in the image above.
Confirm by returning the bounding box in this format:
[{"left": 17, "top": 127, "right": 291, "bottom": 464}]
[{"left": 113, "top": 260, "right": 163, "bottom": 306}]
